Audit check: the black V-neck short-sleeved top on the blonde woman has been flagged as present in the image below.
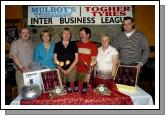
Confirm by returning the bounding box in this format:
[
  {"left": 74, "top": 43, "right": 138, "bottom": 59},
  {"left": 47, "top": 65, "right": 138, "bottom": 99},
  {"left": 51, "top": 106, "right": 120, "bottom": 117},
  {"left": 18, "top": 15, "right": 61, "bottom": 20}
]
[{"left": 54, "top": 41, "right": 78, "bottom": 70}]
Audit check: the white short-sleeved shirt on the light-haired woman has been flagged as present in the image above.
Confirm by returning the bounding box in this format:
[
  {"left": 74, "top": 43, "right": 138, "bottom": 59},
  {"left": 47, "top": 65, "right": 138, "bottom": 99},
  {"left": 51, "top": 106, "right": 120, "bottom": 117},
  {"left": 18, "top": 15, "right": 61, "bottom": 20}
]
[{"left": 97, "top": 46, "right": 118, "bottom": 71}]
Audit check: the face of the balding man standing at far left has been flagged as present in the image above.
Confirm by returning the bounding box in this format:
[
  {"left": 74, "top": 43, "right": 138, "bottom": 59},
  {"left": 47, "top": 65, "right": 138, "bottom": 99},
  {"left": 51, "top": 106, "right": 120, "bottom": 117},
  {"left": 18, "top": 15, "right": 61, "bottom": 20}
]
[{"left": 20, "top": 28, "right": 30, "bottom": 41}]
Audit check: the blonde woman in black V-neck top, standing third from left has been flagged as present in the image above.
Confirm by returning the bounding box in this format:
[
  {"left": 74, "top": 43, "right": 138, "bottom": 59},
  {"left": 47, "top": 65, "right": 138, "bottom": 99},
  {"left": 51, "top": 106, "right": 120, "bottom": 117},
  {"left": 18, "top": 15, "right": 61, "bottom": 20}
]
[{"left": 54, "top": 28, "right": 78, "bottom": 92}]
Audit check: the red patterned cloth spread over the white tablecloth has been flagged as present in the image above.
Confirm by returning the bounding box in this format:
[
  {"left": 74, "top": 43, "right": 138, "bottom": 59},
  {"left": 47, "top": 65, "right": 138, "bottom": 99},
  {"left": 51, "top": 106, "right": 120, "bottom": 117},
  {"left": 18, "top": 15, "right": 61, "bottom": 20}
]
[{"left": 20, "top": 82, "right": 133, "bottom": 105}]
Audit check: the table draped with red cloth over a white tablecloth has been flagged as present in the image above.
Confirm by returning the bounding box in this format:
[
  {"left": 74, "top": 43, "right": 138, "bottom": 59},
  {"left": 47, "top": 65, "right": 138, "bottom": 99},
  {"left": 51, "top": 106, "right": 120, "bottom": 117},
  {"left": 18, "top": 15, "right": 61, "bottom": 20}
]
[{"left": 10, "top": 86, "right": 153, "bottom": 105}]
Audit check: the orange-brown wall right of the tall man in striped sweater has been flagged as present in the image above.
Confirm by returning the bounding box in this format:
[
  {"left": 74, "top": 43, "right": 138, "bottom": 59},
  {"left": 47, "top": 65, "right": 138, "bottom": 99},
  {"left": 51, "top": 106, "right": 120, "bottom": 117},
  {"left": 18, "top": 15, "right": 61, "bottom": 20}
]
[{"left": 135, "top": 5, "right": 155, "bottom": 46}]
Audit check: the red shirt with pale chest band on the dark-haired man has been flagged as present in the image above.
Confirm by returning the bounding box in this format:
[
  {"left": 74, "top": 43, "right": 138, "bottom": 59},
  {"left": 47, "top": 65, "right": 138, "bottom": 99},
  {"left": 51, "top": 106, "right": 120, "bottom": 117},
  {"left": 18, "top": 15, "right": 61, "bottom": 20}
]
[{"left": 77, "top": 41, "right": 97, "bottom": 73}]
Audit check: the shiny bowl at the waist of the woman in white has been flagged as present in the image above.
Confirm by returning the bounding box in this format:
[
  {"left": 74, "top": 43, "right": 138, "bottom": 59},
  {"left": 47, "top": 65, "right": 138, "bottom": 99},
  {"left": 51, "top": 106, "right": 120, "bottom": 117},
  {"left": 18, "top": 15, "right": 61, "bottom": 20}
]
[{"left": 97, "top": 71, "right": 112, "bottom": 79}]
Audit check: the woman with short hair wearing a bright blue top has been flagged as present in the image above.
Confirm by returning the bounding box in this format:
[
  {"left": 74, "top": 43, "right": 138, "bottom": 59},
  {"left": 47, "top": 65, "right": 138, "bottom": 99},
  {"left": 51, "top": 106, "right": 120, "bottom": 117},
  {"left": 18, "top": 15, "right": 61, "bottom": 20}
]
[{"left": 34, "top": 30, "right": 56, "bottom": 69}]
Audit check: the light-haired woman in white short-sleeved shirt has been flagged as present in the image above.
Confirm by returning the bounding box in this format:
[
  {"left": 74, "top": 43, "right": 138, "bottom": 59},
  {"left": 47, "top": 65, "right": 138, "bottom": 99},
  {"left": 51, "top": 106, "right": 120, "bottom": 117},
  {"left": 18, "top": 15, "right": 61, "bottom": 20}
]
[{"left": 93, "top": 35, "right": 118, "bottom": 88}]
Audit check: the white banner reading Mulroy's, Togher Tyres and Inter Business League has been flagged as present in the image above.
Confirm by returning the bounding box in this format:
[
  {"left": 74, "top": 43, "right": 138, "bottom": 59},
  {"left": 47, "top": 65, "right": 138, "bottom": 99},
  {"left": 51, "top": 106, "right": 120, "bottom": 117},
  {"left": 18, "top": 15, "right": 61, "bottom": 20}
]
[{"left": 28, "top": 5, "right": 132, "bottom": 25}]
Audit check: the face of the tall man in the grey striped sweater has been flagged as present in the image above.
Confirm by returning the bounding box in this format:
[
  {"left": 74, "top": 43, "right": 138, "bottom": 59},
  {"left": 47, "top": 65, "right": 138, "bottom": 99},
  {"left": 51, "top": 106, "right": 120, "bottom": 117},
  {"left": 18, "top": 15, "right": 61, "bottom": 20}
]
[{"left": 123, "top": 19, "right": 134, "bottom": 32}]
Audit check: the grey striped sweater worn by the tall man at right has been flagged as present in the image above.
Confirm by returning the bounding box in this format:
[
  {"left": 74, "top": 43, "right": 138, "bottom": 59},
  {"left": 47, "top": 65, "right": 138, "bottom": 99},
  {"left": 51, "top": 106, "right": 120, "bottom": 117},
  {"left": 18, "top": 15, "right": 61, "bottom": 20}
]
[{"left": 113, "top": 31, "right": 149, "bottom": 66}]
